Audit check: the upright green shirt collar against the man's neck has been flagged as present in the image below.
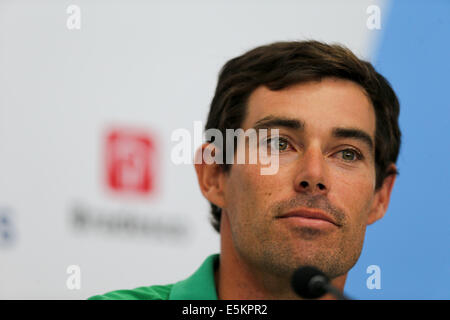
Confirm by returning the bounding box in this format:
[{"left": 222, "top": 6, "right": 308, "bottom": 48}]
[{"left": 169, "top": 254, "right": 219, "bottom": 300}]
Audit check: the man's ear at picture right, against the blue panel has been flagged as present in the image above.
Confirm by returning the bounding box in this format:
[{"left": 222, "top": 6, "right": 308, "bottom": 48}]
[{"left": 367, "top": 164, "right": 397, "bottom": 225}]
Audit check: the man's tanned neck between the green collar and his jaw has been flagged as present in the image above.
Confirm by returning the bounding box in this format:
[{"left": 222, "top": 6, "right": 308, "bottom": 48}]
[{"left": 215, "top": 212, "right": 347, "bottom": 300}]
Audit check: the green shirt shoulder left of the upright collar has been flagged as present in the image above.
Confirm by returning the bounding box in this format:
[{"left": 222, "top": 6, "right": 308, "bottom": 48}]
[{"left": 88, "top": 284, "right": 173, "bottom": 300}]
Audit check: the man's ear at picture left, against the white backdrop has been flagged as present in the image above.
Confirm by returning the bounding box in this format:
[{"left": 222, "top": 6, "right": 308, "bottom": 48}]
[{"left": 194, "top": 143, "right": 225, "bottom": 208}]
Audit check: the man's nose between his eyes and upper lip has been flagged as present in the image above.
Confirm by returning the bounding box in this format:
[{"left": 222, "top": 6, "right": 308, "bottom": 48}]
[{"left": 294, "top": 148, "right": 329, "bottom": 195}]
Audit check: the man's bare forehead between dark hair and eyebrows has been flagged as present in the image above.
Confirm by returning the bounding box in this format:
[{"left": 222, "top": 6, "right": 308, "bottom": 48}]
[{"left": 242, "top": 78, "right": 375, "bottom": 137}]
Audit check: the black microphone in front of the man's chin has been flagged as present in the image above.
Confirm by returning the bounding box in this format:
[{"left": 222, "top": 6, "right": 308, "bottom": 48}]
[{"left": 291, "top": 266, "right": 350, "bottom": 300}]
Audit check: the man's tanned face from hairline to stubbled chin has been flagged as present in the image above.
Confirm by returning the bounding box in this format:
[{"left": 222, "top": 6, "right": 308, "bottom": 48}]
[{"left": 222, "top": 78, "right": 376, "bottom": 278}]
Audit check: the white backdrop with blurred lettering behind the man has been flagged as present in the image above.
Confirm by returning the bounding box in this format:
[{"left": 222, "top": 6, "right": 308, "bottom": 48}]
[{"left": 0, "top": 0, "right": 388, "bottom": 299}]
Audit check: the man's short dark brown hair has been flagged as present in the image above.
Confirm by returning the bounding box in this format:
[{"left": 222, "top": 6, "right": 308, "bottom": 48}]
[{"left": 205, "top": 41, "right": 401, "bottom": 232}]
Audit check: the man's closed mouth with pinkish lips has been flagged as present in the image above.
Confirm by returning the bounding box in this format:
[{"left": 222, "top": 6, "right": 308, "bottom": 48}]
[{"left": 277, "top": 208, "right": 340, "bottom": 227}]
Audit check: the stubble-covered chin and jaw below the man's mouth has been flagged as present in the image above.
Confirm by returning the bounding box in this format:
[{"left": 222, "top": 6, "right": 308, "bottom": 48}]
[{"left": 232, "top": 206, "right": 365, "bottom": 281}]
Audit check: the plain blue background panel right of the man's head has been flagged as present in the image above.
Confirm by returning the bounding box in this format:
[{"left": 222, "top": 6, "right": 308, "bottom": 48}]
[{"left": 346, "top": 0, "right": 450, "bottom": 299}]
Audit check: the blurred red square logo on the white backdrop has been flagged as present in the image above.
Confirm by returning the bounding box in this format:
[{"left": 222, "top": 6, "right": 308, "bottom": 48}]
[{"left": 106, "top": 130, "right": 155, "bottom": 194}]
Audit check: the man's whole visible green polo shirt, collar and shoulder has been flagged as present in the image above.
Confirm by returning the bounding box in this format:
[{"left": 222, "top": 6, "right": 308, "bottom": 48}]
[{"left": 88, "top": 254, "right": 219, "bottom": 300}]
